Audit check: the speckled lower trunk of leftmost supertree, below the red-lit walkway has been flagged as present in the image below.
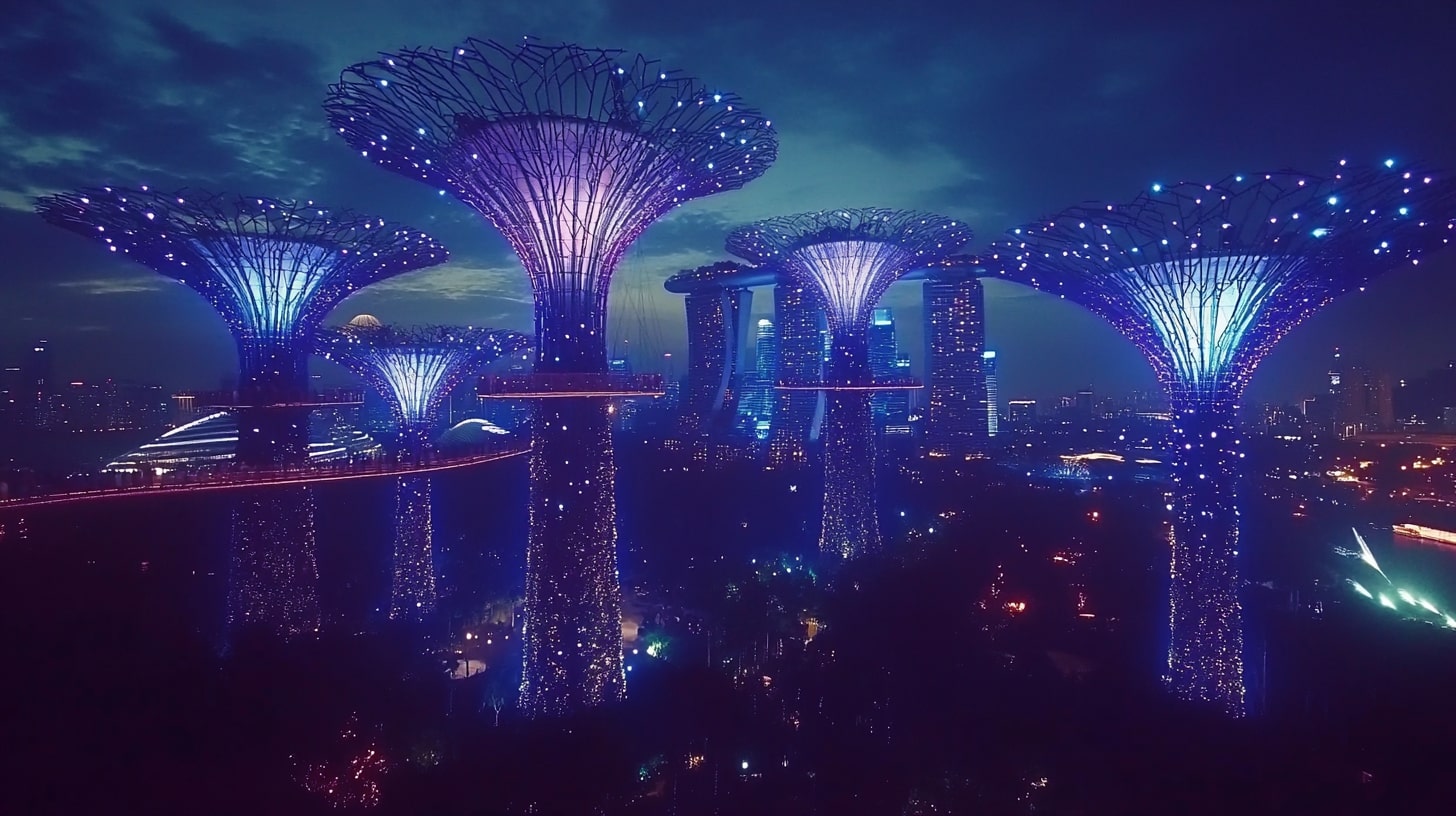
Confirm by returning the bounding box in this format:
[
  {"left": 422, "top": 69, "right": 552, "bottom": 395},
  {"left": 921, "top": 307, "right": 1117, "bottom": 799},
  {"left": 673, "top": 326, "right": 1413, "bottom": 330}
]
[{"left": 227, "top": 485, "right": 322, "bottom": 638}]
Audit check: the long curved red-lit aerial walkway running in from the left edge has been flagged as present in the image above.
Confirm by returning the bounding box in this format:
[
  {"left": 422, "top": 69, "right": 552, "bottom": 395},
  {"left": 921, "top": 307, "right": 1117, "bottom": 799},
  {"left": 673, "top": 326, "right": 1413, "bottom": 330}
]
[{"left": 0, "top": 444, "right": 530, "bottom": 513}]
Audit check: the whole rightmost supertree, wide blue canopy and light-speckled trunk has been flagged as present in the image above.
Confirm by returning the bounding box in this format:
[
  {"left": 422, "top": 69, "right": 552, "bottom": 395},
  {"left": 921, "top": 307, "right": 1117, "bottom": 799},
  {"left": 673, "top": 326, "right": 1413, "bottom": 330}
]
[{"left": 983, "top": 162, "right": 1452, "bottom": 715}]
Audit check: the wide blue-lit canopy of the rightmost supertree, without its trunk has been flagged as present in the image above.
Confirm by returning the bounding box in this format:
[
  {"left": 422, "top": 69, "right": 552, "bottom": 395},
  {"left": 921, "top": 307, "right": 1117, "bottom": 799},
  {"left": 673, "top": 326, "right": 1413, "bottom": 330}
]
[{"left": 983, "top": 160, "right": 1452, "bottom": 409}]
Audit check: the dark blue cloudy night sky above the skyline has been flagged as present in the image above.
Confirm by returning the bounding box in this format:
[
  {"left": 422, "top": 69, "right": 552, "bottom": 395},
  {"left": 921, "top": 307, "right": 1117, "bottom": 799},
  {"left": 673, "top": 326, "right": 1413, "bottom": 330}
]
[{"left": 0, "top": 0, "right": 1456, "bottom": 399}]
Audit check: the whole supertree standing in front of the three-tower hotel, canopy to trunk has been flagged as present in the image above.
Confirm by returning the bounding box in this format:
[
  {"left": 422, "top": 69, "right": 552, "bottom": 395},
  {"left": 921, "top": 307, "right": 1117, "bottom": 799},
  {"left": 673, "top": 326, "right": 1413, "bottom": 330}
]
[{"left": 728, "top": 208, "right": 971, "bottom": 558}]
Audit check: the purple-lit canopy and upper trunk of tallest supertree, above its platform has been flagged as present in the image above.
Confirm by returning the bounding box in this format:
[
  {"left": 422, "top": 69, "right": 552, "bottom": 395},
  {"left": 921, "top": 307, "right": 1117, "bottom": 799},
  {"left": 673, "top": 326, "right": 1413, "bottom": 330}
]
[{"left": 325, "top": 39, "right": 778, "bottom": 372}]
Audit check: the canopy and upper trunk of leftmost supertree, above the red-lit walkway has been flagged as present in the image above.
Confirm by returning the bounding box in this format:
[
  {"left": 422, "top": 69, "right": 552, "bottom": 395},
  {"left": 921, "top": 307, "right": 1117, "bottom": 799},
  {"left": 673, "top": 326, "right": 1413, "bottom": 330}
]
[{"left": 36, "top": 187, "right": 448, "bottom": 466}]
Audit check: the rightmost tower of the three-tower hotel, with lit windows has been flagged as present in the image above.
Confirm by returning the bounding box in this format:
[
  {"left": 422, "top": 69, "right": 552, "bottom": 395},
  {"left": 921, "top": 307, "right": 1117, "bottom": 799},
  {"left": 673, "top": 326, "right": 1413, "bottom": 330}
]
[{"left": 922, "top": 270, "right": 987, "bottom": 456}]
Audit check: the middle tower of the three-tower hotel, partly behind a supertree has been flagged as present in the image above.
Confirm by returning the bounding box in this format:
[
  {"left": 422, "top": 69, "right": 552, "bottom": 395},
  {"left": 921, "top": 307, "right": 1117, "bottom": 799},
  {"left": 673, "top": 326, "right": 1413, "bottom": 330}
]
[{"left": 769, "top": 281, "right": 824, "bottom": 469}]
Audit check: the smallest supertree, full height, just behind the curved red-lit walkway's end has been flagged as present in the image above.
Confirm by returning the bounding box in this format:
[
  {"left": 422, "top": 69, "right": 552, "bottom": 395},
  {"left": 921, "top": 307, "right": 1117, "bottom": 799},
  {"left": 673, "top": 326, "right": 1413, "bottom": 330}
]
[{"left": 317, "top": 321, "right": 530, "bottom": 619}]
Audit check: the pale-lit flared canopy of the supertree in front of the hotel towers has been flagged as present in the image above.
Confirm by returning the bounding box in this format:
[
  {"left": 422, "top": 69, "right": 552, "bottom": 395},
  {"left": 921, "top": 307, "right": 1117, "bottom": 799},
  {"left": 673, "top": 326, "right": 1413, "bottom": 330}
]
[{"left": 728, "top": 208, "right": 971, "bottom": 385}]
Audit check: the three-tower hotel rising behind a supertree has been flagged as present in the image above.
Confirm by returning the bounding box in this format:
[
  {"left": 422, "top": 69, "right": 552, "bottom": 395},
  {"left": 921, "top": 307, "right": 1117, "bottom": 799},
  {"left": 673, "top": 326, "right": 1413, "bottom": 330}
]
[{"left": 664, "top": 256, "right": 994, "bottom": 468}]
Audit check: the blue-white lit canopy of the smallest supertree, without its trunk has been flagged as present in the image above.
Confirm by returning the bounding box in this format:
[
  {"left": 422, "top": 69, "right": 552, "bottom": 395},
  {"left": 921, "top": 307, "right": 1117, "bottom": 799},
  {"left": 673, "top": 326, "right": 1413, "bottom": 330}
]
[{"left": 317, "top": 321, "right": 530, "bottom": 443}]
